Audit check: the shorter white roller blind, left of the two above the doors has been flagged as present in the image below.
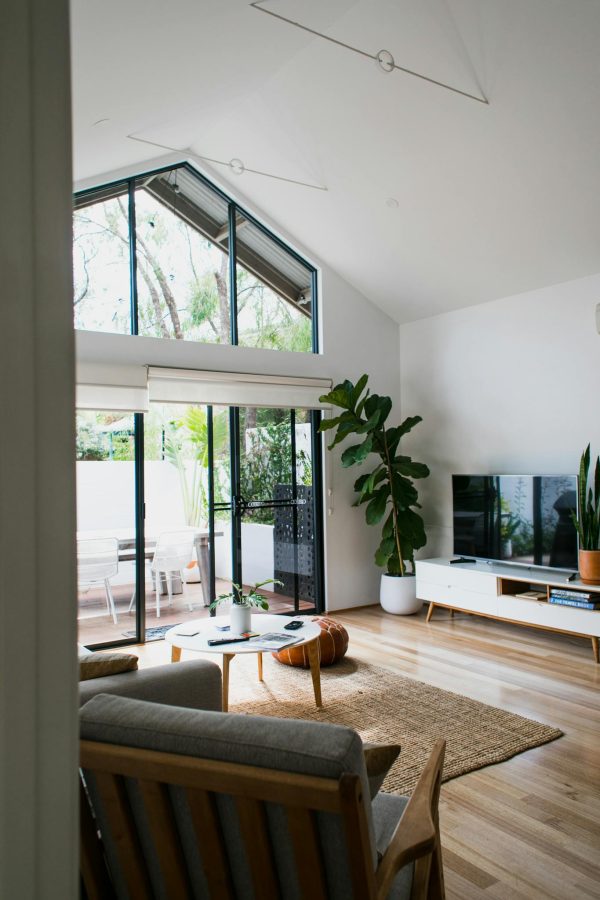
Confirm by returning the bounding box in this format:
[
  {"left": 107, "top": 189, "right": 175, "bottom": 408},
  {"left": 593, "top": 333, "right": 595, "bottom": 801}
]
[{"left": 75, "top": 363, "right": 148, "bottom": 412}]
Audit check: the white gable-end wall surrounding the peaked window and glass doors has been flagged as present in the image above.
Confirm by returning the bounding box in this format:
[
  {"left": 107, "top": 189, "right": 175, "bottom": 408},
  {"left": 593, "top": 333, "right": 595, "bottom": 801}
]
[{"left": 76, "top": 156, "right": 400, "bottom": 610}]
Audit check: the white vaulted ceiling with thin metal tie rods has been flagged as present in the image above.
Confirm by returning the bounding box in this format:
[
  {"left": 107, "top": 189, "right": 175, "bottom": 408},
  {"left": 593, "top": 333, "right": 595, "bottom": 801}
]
[{"left": 72, "top": 0, "right": 600, "bottom": 322}]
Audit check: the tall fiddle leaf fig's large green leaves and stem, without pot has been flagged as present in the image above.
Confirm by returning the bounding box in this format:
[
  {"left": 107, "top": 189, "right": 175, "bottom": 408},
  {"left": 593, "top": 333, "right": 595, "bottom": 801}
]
[{"left": 319, "top": 375, "right": 429, "bottom": 575}]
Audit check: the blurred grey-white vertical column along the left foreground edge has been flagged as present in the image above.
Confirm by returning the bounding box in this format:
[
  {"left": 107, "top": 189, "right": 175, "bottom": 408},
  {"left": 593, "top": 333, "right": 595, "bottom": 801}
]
[{"left": 0, "top": 0, "right": 78, "bottom": 900}]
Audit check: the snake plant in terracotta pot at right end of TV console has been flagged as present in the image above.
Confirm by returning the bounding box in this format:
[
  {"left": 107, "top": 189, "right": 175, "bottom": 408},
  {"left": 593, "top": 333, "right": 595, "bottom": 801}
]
[{"left": 571, "top": 444, "right": 600, "bottom": 584}]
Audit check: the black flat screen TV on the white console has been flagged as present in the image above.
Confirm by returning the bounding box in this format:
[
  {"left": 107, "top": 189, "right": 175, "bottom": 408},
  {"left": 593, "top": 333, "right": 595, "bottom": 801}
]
[{"left": 452, "top": 475, "right": 577, "bottom": 571}]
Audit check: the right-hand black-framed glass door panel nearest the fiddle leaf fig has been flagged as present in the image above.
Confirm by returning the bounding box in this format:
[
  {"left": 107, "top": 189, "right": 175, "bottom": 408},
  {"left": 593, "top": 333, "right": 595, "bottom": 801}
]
[{"left": 214, "top": 407, "right": 322, "bottom": 614}]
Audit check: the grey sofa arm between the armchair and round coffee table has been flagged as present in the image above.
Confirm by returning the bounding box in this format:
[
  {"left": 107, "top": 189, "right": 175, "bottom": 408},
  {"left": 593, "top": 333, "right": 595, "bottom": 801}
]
[{"left": 79, "top": 659, "right": 222, "bottom": 711}]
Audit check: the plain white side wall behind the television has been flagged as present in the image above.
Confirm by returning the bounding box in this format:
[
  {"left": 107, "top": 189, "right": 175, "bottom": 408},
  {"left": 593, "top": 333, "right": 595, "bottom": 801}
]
[{"left": 400, "top": 275, "right": 600, "bottom": 557}]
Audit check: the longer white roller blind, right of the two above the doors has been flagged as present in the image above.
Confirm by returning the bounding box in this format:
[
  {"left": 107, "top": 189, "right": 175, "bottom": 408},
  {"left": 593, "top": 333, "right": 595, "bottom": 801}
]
[{"left": 148, "top": 366, "right": 332, "bottom": 409}]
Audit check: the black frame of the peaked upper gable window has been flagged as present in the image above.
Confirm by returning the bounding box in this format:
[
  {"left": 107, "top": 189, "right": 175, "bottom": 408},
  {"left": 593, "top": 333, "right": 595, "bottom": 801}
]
[{"left": 75, "top": 162, "right": 319, "bottom": 354}]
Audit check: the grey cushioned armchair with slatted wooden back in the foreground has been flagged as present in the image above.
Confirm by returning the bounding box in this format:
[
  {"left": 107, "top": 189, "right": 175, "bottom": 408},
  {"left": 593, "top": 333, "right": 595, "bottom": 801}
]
[{"left": 81, "top": 692, "right": 444, "bottom": 900}]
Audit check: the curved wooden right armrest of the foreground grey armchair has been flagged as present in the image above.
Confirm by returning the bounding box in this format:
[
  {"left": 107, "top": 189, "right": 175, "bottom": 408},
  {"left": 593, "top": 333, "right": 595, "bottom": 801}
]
[{"left": 376, "top": 741, "right": 446, "bottom": 900}]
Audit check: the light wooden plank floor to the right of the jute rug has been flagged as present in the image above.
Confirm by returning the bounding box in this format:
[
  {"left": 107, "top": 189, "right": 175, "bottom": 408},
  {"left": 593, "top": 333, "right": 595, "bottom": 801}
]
[{"left": 131, "top": 607, "right": 600, "bottom": 900}]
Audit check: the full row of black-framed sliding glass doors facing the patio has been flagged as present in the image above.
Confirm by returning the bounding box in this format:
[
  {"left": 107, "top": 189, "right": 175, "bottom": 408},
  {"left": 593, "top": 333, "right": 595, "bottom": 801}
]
[{"left": 77, "top": 403, "right": 323, "bottom": 645}]
